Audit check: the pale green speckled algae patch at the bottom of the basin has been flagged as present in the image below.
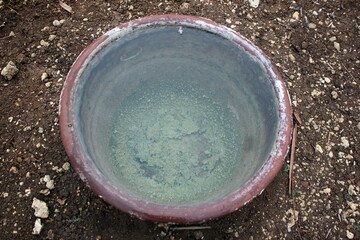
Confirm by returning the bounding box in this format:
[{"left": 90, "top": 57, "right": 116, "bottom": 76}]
[{"left": 110, "top": 81, "right": 241, "bottom": 205}]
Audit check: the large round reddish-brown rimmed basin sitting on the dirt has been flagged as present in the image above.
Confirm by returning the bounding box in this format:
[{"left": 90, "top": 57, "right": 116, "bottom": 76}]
[{"left": 60, "top": 15, "right": 292, "bottom": 223}]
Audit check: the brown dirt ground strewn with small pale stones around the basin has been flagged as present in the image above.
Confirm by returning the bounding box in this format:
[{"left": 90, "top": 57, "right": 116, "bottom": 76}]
[{"left": 0, "top": 0, "right": 360, "bottom": 240}]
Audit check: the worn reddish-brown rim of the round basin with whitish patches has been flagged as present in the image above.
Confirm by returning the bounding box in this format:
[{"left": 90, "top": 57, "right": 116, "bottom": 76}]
[{"left": 59, "top": 15, "right": 292, "bottom": 223}]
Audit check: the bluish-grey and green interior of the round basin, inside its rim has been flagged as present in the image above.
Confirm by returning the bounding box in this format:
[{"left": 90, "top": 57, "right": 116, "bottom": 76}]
[{"left": 76, "top": 26, "right": 278, "bottom": 205}]
